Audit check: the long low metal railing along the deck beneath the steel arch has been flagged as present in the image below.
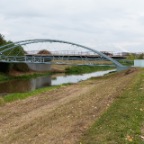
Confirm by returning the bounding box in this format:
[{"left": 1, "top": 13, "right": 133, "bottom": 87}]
[{"left": 0, "top": 55, "right": 111, "bottom": 64}]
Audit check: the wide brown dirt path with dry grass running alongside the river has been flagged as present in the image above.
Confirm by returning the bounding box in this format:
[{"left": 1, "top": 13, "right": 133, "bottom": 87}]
[{"left": 0, "top": 71, "right": 137, "bottom": 144}]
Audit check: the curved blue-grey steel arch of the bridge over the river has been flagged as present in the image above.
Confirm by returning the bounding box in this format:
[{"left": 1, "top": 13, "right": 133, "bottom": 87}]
[{"left": 0, "top": 39, "right": 127, "bottom": 70}]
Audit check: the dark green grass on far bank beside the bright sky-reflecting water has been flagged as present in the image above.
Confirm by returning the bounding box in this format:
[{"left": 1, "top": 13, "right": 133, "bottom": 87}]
[{"left": 66, "top": 66, "right": 114, "bottom": 74}]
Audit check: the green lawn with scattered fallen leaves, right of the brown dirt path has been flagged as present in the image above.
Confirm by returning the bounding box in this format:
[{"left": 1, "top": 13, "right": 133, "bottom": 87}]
[{"left": 80, "top": 70, "right": 144, "bottom": 144}]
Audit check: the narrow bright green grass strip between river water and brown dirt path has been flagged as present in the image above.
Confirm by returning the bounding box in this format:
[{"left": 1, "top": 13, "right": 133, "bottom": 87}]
[{"left": 0, "top": 86, "right": 61, "bottom": 104}]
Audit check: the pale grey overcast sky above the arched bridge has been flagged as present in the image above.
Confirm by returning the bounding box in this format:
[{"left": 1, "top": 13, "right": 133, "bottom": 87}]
[{"left": 0, "top": 0, "right": 144, "bottom": 52}]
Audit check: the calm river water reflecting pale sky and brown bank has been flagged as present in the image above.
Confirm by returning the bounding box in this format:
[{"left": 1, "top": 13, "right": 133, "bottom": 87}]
[{"left": 0, "top": 70, "right": 115, "bottom": 95}]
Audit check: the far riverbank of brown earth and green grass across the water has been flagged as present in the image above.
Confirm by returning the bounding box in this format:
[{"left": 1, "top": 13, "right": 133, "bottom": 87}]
[{"left": 0, "top": 65, "right": 113, "bottom": 82}]
